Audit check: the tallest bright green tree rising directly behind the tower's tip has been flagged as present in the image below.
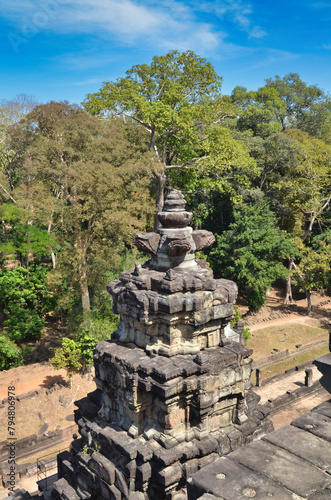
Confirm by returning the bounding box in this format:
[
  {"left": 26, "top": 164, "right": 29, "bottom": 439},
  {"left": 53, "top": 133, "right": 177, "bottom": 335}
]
[{"left": 84, "top": 51, "right": 254, "bottom": 226}]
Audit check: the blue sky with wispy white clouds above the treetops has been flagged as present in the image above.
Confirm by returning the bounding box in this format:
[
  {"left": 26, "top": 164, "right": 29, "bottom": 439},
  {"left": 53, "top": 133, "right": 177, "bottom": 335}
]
[{"left": 0, "top": 0, "right": 331, "bottom": 104}]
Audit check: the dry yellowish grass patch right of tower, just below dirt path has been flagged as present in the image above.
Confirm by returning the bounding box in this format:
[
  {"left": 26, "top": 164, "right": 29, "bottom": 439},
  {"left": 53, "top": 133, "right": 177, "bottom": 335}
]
[{"left": 247, "top": 323, "right": 329, "bottom": 361}]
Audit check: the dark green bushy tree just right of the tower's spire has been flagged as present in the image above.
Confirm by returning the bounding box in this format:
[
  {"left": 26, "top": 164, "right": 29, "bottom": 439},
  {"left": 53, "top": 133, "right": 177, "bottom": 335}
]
[{"left": 208, "top": 201, "right": 296, "bottom": 311}]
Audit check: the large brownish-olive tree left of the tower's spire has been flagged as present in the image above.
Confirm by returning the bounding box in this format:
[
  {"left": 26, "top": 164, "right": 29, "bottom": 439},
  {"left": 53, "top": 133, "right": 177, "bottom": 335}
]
[{"left": 8, "top": 102, "right": 151, "bottom": 310}]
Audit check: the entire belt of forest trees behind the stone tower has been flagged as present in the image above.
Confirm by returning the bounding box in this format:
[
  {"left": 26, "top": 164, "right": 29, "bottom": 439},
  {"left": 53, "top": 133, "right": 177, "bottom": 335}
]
[{"left": 0, "top": 55, "right": 331, "bottom": 376}]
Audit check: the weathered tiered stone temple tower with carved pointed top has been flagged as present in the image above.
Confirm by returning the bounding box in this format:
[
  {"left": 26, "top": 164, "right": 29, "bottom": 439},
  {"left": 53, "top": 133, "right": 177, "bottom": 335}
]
[{"left": 53, "top": 191, "right": 272, "bottom": 500}]
